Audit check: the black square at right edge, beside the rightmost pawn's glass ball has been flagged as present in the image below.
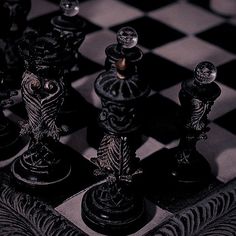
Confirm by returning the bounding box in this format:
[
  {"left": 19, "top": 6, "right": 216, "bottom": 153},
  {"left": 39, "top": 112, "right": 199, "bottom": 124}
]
[{"left": 216, "top": 60, "right": 236, "bottom": 89}]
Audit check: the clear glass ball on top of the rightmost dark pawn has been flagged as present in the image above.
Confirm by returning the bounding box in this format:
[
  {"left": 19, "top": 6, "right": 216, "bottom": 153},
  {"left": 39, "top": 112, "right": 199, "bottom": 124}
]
[{"left": 194, "top": 61, "right": 217, "bottom": 84}]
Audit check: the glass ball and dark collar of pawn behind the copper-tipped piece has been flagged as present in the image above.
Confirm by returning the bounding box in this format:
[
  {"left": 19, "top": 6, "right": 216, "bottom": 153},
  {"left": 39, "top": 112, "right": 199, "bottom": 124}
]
[{"left": 105, "top": 26, "right": 143, "bottom": 70}]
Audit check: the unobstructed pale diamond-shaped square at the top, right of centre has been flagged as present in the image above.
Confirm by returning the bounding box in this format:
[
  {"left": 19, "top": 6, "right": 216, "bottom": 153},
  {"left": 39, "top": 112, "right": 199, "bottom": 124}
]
[{"left": 149, "top": 2, "right": 224, "bottom": 34}]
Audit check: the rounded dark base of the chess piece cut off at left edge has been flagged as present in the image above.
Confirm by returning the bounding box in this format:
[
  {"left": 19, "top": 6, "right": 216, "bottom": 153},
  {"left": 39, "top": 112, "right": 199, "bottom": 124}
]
[{"left": 0, "top": 118, "right": 27, "bottom": 167}]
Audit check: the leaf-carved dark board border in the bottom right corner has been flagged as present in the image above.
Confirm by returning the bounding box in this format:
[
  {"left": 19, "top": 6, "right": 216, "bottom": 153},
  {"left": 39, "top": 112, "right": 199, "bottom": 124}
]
[{"left": 146, "top": 183, "right": 236, "bottom": 236}]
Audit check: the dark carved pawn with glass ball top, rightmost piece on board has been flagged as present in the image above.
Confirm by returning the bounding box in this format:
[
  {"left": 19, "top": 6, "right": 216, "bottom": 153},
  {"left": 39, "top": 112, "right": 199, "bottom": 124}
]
[{"left": 171, "top": 61, "right": 221, "bottom": 183}]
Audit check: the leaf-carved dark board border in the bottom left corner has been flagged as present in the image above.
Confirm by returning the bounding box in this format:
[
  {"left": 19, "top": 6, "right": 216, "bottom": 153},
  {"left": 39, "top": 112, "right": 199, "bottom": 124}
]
[{"left": 0, "top": 186, "right": 86, "bottom": 236}]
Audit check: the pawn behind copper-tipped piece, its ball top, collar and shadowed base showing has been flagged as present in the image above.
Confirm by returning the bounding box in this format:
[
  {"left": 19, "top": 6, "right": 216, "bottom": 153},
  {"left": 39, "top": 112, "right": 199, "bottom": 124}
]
[{"left": 87, "top": 26, "right": 143, "bottom": 148}]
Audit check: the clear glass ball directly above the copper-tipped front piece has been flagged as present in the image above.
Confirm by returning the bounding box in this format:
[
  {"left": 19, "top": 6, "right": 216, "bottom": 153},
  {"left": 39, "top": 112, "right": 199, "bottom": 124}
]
[{"left": 117, "top": 26, "right": 138, "bottom": 48}]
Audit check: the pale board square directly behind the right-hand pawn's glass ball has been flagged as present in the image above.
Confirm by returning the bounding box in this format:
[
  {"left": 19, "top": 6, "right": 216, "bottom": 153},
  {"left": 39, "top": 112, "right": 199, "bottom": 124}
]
[{"left": 153, "top": 36, "right": 236, "bottom": 70}]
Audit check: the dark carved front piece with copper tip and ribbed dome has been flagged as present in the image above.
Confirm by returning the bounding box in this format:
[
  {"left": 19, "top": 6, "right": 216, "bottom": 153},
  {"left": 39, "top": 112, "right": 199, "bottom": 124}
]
[{"left": 82, "top": 59, "right": 149, "bottom": 235}]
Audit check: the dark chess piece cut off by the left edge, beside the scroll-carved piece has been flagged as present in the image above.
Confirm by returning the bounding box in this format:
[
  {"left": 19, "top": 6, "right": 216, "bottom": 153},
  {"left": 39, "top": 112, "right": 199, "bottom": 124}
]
[{"left": 0, "top": 72, "right": 26, "bottom": 167}]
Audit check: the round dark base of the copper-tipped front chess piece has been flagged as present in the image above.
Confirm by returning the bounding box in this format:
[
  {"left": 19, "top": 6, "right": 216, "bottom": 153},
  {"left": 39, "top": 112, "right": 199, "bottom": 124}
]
[{"left": 82, "top": 183, "right": 145, "bottom": 235}]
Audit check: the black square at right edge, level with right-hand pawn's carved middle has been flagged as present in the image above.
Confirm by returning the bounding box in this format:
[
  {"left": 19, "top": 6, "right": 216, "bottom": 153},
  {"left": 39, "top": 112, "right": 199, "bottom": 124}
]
[{"left": 214, "top": 109, "right": 236, "bottom": 134}]
